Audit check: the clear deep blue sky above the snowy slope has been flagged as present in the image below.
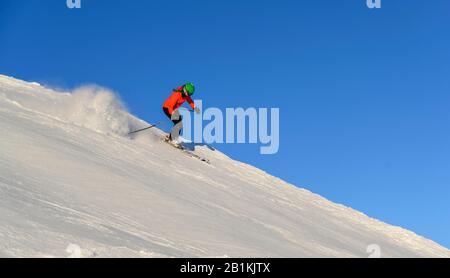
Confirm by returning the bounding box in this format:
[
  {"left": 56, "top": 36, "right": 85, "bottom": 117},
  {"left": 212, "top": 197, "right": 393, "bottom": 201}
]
[{"left": 0, "top": 0, "right": 450, "bottom": 247}]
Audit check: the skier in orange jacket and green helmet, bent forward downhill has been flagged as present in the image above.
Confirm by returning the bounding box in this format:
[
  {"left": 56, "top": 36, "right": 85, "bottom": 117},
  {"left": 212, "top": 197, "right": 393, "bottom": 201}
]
[{"left": 163, "top": 83, "right": 200, "bottom": 141}]
